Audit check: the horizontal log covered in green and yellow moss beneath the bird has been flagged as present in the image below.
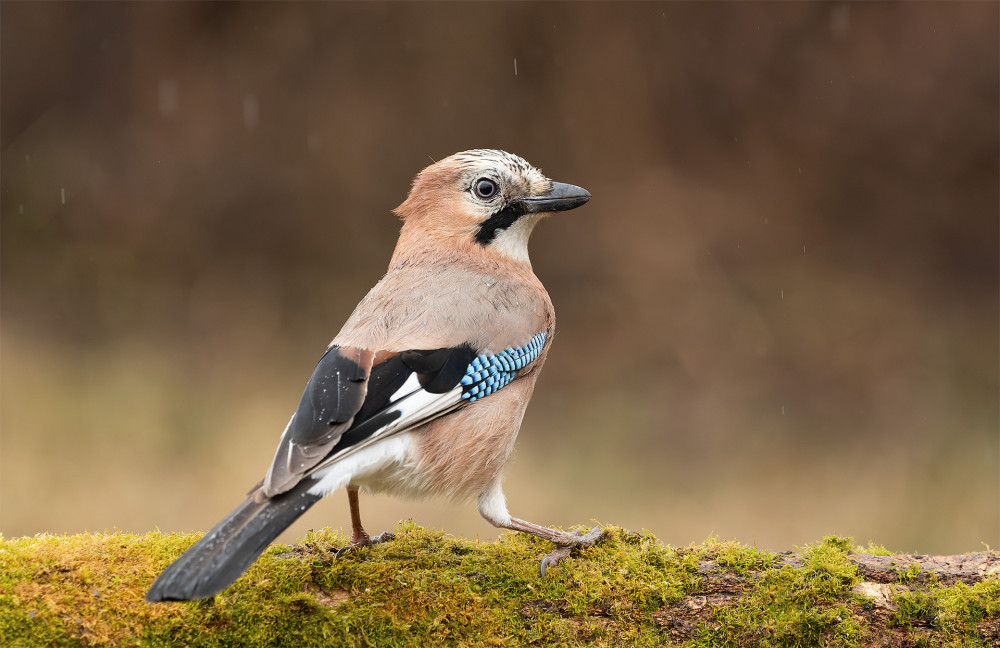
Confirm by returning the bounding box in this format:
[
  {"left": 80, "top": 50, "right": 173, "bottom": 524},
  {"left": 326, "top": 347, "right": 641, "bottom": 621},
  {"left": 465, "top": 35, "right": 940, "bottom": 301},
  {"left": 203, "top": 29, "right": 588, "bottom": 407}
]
[{"left": 0, "top": 523, "right": 1000, "bottom": 648}]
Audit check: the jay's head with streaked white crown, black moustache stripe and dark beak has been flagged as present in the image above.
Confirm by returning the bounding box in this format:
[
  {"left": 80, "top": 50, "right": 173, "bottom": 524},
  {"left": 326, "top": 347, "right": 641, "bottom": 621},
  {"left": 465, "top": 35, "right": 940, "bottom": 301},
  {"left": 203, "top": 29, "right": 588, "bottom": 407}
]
[{"left": 395, "top": 149, "right": 590, "bottom": 263}]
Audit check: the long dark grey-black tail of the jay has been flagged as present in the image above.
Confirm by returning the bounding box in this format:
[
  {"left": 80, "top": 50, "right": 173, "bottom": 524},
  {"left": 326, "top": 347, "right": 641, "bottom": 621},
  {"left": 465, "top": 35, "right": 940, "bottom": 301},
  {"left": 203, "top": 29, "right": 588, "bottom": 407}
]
[{"left": 146, "top": 479, "right": 321, "bottom": 603}]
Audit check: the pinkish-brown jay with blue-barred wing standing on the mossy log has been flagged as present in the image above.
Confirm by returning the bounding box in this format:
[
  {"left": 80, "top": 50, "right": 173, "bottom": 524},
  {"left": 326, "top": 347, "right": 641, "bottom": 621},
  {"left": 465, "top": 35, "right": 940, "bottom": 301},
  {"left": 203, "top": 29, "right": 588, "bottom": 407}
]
[{"left": 146, "top": 149, "right": 603, "bottom": 602}]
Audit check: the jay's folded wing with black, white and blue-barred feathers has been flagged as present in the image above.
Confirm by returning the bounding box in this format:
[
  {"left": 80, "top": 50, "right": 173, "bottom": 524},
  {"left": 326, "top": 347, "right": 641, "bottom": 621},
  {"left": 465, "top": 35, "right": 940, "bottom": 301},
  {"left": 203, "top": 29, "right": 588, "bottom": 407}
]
[{"left": 257, "top": 331, "right": 547, "bottom": 499}]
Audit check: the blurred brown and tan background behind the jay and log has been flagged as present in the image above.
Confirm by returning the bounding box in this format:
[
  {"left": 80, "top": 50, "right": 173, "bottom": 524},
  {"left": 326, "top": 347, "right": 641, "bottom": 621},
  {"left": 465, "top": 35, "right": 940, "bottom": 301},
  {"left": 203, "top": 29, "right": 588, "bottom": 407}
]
[{"left": 0, "top": 2, "right": 1000, "bottom": 553}]
